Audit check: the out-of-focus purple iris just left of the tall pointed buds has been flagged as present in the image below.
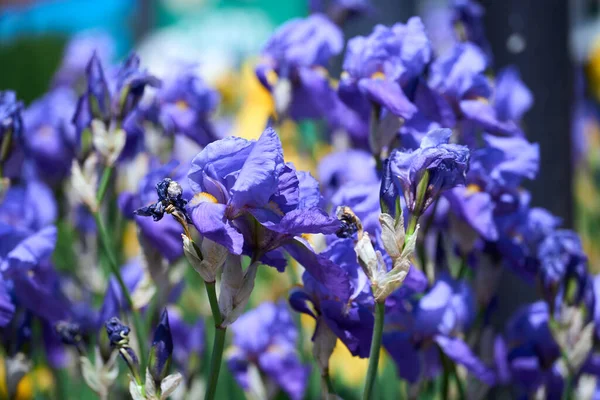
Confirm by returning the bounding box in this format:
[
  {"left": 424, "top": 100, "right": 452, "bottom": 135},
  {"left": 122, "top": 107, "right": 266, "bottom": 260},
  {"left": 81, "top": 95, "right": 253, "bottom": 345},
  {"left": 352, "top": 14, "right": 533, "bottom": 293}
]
[{"left": 23, "top": 88, "right": 78, "bottom": 182}]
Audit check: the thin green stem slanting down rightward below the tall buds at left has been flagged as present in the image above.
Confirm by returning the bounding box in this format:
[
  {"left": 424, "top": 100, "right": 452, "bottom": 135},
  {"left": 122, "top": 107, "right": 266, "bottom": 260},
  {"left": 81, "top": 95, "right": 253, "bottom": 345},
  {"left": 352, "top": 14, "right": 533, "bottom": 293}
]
[{"left": 92, "top": 211, "right": 146, "bottom": 371}]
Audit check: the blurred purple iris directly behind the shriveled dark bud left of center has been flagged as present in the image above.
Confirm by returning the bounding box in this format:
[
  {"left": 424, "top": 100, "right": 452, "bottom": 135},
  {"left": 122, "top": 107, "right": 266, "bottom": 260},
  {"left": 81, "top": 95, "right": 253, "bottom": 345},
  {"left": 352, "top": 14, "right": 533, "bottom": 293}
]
[{"left": 119, "top": 161, "right": 192, "bottom": 261}]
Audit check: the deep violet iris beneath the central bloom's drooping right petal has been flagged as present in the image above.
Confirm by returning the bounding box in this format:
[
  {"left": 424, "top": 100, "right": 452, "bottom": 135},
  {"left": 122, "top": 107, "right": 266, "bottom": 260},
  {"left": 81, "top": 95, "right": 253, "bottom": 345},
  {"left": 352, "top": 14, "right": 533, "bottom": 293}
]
[{"left": 289, "top": 239, "right": 374, "bottom": 358}]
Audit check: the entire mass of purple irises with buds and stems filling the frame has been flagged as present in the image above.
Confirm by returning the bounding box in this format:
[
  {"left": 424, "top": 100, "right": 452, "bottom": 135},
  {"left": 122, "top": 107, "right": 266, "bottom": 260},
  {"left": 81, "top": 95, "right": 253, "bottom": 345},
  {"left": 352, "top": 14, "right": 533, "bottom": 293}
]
[{"left": 0, "top": 1, "right": 600, "bottom": 400}]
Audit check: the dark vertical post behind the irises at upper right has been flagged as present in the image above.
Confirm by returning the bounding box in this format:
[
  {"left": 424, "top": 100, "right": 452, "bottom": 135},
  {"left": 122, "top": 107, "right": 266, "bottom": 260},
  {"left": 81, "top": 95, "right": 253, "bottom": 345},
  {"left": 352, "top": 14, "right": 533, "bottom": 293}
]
[{"left": 481, "top": 0, "right": 574, "bottom": 227}]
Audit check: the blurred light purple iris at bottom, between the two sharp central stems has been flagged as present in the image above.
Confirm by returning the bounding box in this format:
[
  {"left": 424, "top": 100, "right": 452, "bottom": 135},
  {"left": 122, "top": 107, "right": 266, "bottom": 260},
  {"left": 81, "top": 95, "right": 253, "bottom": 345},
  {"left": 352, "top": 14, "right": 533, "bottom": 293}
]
[{"left": 227, "top": 302, "right": 310, "bottom": 400}]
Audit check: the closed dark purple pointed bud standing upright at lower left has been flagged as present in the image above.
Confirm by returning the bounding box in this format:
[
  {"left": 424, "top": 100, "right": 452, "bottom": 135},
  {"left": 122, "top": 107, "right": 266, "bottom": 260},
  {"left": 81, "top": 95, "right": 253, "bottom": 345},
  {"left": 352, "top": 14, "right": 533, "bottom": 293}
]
[{"left": 148, "top": 309, "right": 173, "bottom": 386}]
